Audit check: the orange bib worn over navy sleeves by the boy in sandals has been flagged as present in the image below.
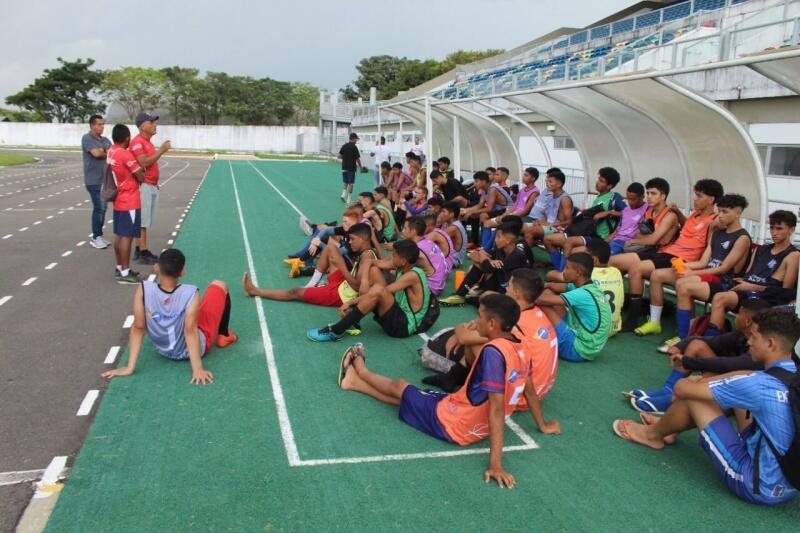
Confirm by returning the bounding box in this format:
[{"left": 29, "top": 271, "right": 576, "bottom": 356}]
[{"left": 436, "top": 339, "right": 531, "bottom": 446}]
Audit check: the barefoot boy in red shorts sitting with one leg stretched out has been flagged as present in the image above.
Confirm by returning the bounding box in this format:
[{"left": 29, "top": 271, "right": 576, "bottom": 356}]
[{"left": 242, "top": 221, "right": 378, "bottom": 307}]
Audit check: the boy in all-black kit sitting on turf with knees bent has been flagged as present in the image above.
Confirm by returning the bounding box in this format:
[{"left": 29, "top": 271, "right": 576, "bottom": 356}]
[{"left": 439, "top": 218, "right": 531, "bottom": 306}]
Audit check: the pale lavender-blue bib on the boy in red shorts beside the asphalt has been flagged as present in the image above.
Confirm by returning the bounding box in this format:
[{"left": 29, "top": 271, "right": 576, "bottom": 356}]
[{"left": 142, "top": 281, "right": 206, "bottom": 359}]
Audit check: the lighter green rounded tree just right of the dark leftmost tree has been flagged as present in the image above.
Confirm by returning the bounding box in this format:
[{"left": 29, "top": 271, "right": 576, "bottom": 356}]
[{"left": 101, "top": 67, "right": 166, "bottom": 120}]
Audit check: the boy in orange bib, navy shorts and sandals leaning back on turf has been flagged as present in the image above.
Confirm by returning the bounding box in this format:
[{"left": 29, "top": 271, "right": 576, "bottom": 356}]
[{"left": 339, "top": 294, "right": 561, "bottom": 488}]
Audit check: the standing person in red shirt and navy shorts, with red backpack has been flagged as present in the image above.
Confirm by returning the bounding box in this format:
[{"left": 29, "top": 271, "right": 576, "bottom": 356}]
[{"left": 106, "top": 124, "right": 144, "bottom": 284}]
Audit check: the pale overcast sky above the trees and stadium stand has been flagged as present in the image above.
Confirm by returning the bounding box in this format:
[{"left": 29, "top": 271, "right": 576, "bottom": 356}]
[{"left": 0, "top": 0, "right": 634, "bottom": 106}]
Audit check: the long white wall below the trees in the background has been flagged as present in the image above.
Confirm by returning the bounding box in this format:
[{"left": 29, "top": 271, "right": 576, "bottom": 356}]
[{"left": 0, "top": 122, "right": 319, "bottom": 153}]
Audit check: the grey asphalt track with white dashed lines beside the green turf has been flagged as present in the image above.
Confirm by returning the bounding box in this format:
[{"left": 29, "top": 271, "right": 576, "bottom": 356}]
[{"left": 0, "top": 151, "right": 210, "bottom": 532}]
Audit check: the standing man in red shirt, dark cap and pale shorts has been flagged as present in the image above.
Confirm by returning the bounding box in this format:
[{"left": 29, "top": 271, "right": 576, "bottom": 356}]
[{"left": 130, "top": 113, "right": 172, "bottom": 265}]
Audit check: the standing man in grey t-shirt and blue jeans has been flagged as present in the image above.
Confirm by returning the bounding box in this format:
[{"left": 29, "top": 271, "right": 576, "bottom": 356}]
[{"left": 81, "top": 115, "right": 111, "bottom": 250}]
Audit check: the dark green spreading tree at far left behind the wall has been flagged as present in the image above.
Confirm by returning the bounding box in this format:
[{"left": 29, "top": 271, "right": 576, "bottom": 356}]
[{"left": 6, "top": 57, "right": 105, "bottom": 122}]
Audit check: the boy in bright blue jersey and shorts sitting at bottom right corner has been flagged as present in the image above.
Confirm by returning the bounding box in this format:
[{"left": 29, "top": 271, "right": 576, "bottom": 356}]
[{"left": 613, "top": 308, "right": 800, "bottom": 505}]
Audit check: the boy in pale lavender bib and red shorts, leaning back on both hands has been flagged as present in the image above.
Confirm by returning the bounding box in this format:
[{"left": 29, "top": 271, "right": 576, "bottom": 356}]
[{"left": 102, "top": 248, "right": 238, "bottom": 384}]
